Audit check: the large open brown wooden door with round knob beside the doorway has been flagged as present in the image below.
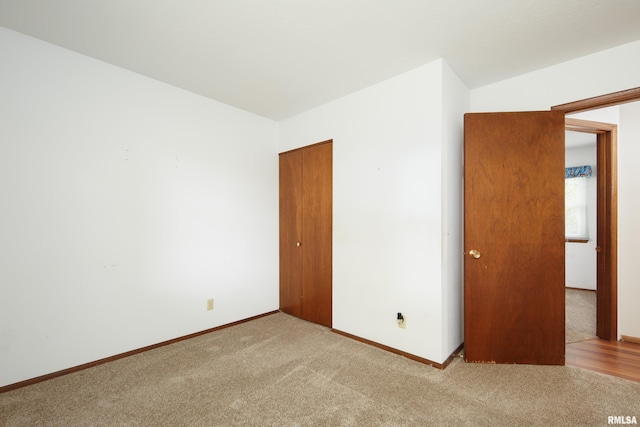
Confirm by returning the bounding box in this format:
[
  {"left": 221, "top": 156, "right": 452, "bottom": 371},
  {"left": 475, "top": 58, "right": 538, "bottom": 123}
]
[{"left": 464, "top": 111, "right": 565, "bottom": 365}]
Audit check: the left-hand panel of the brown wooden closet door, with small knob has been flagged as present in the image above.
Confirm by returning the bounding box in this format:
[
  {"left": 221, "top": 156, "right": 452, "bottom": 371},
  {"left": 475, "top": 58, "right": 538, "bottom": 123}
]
[{"left": 280, "top": 150, "right": 302, "bottom": 317}]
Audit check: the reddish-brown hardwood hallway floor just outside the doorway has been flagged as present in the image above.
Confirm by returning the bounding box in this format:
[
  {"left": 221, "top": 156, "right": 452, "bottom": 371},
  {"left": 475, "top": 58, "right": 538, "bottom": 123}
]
[{"left": 565, "top": 339, "right": 640, "bottom": 382}]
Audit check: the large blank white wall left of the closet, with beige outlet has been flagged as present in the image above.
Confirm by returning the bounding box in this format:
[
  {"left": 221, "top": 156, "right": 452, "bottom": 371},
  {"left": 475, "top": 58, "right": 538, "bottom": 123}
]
[{"left": 0, "top": 28, "right": 278, "bottom": 386}]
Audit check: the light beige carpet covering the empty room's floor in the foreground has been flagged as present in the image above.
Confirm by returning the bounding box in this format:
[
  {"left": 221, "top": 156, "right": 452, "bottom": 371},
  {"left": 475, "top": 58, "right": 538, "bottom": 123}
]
[{"left": 0, "top": 313, "right": 640, "bottom": 426}]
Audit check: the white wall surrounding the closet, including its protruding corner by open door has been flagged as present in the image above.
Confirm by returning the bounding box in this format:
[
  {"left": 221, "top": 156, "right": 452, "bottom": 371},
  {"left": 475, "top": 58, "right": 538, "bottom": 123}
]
[{"left": 280, "top": 60, "right": 468, "bottom": 363}]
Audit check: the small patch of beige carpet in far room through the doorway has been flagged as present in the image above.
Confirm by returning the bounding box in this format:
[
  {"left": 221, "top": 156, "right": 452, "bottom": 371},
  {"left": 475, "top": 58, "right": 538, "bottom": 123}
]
[{"left": 565, "top": 288, "right": 597, "bottom": 344}]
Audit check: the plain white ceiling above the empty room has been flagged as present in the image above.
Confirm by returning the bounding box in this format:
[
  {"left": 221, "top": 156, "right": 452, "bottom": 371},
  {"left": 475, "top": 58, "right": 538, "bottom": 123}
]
[{"left": 0, "top": 0, "right": 640, "bottom": 120}]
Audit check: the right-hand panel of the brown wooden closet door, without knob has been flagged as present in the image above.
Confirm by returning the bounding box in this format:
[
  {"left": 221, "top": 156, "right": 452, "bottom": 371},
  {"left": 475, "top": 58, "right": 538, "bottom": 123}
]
[{"left": 301, "top": 142, "right": 333, "bottom": 327}]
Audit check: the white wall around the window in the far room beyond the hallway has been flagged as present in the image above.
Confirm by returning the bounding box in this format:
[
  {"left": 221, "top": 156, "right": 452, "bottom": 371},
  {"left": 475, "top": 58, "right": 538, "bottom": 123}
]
[{"left": 564, "top": 143, "right": 598, "bottom": 290}]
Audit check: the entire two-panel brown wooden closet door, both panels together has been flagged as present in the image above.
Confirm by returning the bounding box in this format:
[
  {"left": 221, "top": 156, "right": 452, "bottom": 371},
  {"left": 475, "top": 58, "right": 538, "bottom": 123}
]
[{"left": 280, "top": 141, "right": 333, "bottom": 327}]
